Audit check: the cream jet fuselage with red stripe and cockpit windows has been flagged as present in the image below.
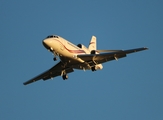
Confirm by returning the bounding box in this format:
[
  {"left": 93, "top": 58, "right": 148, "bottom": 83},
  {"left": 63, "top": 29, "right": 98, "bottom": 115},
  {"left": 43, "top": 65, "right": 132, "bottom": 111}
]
[{"left": 43, "top": 35, "right": 91, "bottom": 69}]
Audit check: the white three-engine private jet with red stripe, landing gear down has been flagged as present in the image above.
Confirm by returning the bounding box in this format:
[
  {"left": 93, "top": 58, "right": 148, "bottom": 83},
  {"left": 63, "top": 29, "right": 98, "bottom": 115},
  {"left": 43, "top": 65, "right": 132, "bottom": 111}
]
[{"left": 23, "top": 35, "right": 148, "bottom": 85}]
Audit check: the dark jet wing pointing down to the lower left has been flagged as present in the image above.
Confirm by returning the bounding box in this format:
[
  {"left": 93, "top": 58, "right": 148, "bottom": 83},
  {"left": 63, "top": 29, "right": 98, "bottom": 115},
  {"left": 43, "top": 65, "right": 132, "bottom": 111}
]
[{"left": 23, "top": 62, "right": 74, "bottom": 85}]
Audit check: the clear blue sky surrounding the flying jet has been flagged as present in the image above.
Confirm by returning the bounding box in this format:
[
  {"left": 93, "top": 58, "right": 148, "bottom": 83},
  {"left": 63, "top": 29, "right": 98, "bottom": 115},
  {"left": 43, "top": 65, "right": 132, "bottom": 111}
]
[{"left": 0, "top": 0, "right": 163, "bottom": 120}]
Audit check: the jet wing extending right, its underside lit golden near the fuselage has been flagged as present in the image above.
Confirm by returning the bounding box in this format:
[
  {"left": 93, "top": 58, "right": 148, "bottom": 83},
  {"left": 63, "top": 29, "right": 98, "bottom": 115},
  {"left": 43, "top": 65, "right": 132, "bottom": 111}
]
[{"left": 77, "top": 48, "right": 148, "bottom": 66}]
